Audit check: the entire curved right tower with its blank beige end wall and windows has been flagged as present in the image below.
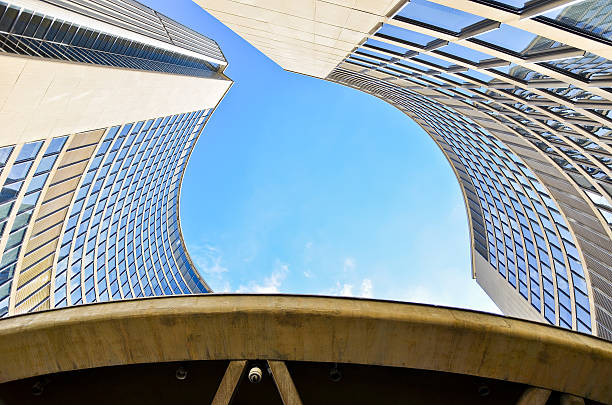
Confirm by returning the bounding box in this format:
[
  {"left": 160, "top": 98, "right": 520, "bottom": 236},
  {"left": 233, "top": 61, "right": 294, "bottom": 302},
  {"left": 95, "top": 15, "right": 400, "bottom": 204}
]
[{"left": 195, "top": 0, "right": 612, "bottom": 339}]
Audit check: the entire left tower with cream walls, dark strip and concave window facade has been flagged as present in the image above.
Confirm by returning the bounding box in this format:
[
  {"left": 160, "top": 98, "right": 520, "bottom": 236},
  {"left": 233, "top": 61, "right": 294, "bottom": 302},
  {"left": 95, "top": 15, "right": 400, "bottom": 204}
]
[{"left": 0, "top": 0, "right": 232, "bottom": 316}]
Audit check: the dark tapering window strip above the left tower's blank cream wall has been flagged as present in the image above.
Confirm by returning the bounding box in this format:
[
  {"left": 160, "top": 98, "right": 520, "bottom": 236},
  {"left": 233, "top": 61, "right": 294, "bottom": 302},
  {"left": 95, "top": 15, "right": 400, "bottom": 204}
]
[{"left": 0, "top": 2, "right": 220, "bottom": 77}]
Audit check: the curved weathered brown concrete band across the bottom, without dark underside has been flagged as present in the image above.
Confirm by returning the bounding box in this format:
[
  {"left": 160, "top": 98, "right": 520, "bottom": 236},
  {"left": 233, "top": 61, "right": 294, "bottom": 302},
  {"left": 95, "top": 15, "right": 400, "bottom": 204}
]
[{"left": 0, "top": 294, "right": 612, "bottom": 403}]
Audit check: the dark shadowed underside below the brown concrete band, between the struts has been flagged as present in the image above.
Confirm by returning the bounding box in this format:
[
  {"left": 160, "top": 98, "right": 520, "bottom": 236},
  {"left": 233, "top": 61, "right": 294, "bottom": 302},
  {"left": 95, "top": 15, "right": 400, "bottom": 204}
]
[{"left": 0, "top": 360, "right": 596, "bottom": 405}]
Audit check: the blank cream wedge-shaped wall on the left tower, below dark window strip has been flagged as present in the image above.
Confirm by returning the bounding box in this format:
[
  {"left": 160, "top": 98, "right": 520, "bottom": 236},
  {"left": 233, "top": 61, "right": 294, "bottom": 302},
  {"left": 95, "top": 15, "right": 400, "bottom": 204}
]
[{"left": 0, "top": 54, "right": 232, "bottom": 145}]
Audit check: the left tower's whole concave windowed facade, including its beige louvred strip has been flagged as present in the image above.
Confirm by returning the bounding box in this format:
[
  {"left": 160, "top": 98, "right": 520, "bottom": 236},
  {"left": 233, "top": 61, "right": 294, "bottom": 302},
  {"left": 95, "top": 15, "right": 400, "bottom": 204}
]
[{"left": 0, "top": 110, "right": 211, "bottom": 316}]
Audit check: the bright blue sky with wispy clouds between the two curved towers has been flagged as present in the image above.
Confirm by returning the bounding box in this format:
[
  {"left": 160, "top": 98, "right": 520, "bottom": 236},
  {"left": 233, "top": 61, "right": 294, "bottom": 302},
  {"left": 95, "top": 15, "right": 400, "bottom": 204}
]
[{"left": 141, "top": 0, "right": 499, "bottom": 312}]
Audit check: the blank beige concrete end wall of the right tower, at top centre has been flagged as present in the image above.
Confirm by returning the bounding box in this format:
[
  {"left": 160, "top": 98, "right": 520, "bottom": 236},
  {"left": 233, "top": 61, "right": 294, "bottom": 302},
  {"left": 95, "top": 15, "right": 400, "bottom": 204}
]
[{"left": 195, "top": 0, "right": 401, "bottom": 78}]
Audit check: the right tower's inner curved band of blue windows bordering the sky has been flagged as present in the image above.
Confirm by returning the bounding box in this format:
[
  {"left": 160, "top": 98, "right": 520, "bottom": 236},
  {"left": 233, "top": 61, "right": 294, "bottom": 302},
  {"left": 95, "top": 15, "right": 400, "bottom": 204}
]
[{"left": 333, "top": 71, "right": 592, "bottom": 333}]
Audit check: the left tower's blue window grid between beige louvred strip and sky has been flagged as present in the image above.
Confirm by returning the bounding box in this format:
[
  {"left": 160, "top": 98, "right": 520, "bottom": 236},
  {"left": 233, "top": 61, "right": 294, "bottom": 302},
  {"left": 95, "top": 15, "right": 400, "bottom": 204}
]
[{"left": 53, "top": 110, "right": 209, "bottom": 307}]
